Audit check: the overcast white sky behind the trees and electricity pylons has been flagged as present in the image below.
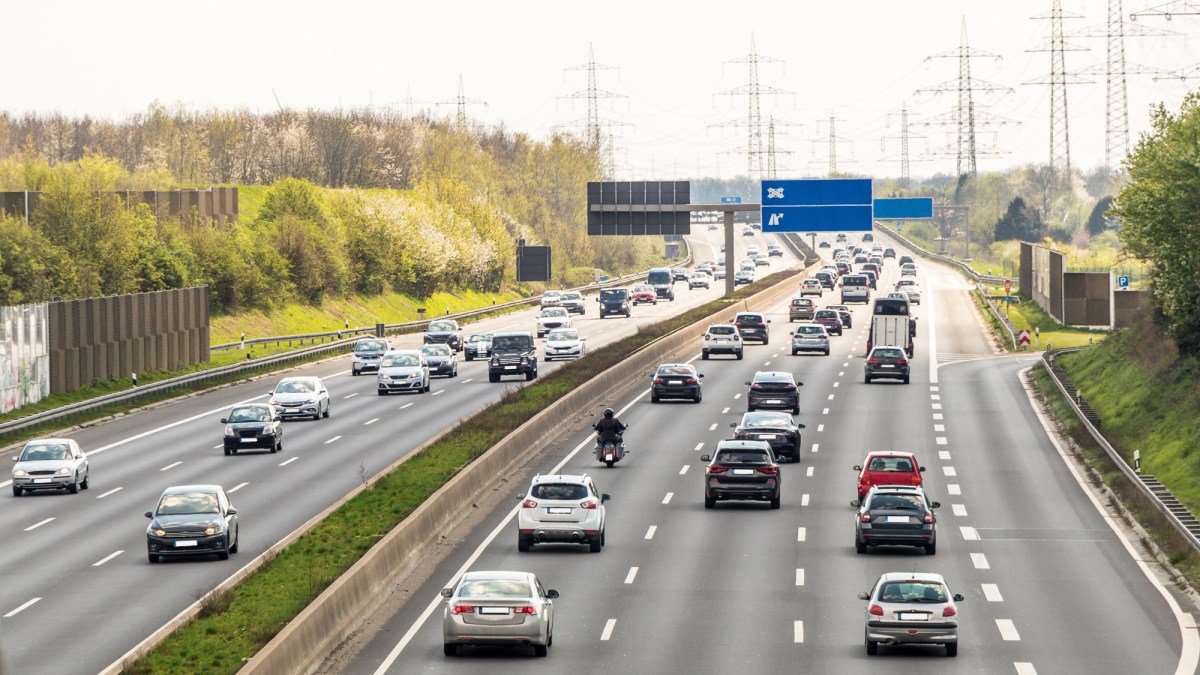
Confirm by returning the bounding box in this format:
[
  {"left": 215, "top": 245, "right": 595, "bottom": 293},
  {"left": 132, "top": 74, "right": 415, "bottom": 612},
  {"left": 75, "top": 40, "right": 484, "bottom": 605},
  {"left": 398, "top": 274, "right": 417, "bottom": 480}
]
[{"left": 9, "top": 0, "right": 1200, "bottom": 179}]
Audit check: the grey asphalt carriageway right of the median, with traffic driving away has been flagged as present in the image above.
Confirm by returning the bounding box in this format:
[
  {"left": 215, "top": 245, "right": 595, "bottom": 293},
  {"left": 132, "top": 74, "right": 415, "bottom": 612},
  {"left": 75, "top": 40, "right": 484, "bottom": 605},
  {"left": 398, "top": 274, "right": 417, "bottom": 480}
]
[{"left": 322, "top": 234, "right": 1200, "bottom": 675}]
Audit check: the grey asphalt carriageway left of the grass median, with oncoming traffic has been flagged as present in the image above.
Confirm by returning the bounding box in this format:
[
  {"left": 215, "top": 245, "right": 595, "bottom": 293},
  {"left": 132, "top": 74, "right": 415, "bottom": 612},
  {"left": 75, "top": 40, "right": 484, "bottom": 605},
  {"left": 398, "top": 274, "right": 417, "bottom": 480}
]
[{"left": 0, "top": 222, "right": 797, "bottom": 675}]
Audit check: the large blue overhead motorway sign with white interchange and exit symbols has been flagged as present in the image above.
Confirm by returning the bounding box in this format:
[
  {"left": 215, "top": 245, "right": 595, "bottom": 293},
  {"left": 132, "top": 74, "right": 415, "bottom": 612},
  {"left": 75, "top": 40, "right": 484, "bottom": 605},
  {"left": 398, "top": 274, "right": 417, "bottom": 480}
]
[{"left": 762, "top": 178, "right": 874, "bottom": 232}]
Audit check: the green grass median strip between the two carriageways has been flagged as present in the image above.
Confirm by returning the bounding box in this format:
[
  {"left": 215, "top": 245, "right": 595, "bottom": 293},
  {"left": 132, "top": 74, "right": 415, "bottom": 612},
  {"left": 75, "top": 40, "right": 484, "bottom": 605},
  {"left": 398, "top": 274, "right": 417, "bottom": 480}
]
[{"left": 125, "top": 271, "right": 793, "bottom": 674}]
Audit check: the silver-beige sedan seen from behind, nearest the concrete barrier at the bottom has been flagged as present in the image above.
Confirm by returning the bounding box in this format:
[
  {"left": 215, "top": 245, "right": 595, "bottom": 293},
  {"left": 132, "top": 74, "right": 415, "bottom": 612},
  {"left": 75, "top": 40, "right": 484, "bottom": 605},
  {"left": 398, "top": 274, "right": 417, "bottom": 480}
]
[{"left": 442, "top": 571, "right": 559, "bottom": 657}]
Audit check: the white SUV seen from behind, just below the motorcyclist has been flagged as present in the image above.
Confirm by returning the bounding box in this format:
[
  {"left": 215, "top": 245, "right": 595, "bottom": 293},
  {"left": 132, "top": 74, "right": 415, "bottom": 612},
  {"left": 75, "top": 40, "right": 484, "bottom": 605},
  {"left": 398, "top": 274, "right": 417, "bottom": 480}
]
[{"left": 517, "top": 473, "right": 610, "bottom": 554}]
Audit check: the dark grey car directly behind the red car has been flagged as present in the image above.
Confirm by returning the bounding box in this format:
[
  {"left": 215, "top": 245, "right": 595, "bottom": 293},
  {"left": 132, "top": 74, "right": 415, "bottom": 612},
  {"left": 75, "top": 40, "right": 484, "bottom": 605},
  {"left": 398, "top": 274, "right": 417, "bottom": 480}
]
[{"left": 850, "top": 485, "right": 942, "bottom": 555}]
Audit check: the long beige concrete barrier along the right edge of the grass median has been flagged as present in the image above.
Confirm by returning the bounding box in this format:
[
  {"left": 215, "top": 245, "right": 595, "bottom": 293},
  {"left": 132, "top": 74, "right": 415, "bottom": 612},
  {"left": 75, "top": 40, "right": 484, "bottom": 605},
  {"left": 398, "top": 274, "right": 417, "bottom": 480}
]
[{"left": 228, "top": 268, "right": 799, "bottom": 675}]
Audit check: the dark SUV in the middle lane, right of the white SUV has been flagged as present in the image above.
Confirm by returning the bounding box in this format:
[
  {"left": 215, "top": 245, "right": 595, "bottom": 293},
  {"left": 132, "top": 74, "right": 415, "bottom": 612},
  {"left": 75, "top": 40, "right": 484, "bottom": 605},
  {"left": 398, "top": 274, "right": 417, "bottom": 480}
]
[{"left": 700, "top": 440, "right": 782, "bottom": 509}]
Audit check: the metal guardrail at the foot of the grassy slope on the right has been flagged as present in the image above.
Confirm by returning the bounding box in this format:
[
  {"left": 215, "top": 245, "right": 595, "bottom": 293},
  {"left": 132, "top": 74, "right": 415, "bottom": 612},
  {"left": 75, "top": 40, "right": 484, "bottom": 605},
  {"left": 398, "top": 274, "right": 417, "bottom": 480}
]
[{"left": 1042, "top": 347, "right": 1200, "bottom": 551}]
